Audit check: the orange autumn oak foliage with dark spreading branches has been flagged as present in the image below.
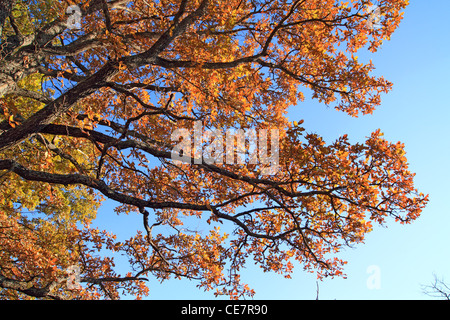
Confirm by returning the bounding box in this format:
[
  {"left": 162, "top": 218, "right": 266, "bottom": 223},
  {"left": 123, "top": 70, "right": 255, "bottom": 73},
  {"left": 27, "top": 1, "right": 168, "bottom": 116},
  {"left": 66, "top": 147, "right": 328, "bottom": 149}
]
[{"left": 0, "top": 0, "right": 427, "bottom": 299}]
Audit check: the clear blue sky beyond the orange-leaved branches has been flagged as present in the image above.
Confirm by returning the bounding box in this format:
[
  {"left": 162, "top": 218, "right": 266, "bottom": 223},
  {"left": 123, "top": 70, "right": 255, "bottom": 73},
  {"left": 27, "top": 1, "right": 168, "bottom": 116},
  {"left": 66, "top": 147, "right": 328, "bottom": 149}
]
[{"left": 93, "top": 0, "right": 450, "bottom": 300}]
